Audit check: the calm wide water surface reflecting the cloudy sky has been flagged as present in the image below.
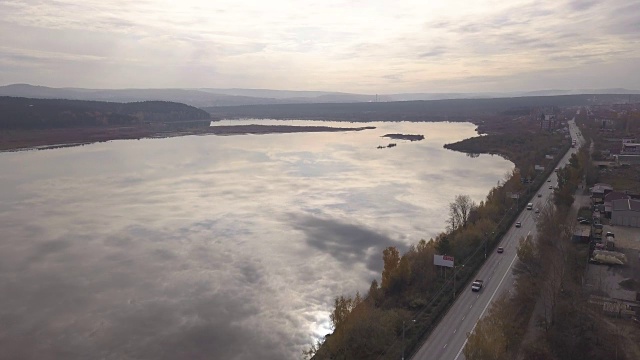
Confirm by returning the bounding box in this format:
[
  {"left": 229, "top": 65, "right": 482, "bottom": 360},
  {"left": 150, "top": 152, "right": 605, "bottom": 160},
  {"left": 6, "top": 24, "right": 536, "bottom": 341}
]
[{"left": 0, "top": 120, "right": 513, "bottom": 359}]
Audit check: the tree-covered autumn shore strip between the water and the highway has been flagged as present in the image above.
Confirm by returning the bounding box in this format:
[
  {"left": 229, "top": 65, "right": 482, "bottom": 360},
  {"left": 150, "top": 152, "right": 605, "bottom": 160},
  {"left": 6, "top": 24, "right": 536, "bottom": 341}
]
[{"left": 306, "top": 118, "right": 568, "bottom": 359}]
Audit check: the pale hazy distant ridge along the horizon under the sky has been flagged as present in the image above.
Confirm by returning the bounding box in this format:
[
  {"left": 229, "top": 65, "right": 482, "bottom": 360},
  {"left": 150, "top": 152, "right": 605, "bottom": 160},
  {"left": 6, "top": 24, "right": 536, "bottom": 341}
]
[{"left": 0, "top": 84, "right": 640, "bottom": 108}]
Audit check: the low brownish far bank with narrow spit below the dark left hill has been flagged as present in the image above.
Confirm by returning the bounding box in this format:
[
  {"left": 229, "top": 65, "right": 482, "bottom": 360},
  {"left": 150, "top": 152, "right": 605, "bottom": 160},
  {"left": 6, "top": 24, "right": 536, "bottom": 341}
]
[{"left": 0, "top": 122, "right": 375, "bottom": 151}]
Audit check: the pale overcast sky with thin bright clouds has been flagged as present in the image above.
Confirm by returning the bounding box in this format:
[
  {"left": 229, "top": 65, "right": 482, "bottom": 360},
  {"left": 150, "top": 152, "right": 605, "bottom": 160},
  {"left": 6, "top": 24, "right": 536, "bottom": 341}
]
[{"left": 0, "top": 0, "right": 640, "bottom": 94}]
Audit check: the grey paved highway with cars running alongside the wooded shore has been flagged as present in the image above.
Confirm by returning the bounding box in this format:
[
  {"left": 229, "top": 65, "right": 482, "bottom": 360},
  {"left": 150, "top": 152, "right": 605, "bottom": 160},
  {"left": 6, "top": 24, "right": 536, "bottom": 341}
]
[{"left": 412, "top": 119, "right": 583, "bottom": 360}]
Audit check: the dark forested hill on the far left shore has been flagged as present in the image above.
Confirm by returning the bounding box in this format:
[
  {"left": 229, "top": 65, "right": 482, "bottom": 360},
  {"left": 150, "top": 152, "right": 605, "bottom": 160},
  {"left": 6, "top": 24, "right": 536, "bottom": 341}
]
[{"left": 0, "top": 96, "right": 210, "bottom": 129}]
